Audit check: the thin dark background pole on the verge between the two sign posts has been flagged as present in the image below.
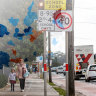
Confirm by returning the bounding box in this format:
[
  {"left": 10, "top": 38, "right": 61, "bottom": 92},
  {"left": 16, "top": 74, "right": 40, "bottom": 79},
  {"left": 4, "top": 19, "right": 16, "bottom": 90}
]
[{"left": 48, "top": 32, "right": 52, "bottom": 82}]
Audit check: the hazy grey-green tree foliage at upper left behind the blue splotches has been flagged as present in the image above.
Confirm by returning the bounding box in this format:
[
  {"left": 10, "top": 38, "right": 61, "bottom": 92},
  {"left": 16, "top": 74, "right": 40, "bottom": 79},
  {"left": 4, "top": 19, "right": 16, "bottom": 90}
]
[{"left": 0, "top": 0, "right": 43, "bottom": 65}]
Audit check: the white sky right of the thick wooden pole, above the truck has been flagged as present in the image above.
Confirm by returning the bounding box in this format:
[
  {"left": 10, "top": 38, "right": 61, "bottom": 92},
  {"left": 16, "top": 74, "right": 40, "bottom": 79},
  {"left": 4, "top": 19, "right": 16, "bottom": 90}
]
[{"left": 74, "top": 0, "right": 96, "bottom": 52}]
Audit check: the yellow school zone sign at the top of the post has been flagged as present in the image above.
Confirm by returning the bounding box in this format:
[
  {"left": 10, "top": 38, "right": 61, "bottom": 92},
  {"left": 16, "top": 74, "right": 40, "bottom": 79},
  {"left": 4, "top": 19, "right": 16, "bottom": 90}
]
[{"left": 44, "top": 0, "right": 66, "bottom": 10}]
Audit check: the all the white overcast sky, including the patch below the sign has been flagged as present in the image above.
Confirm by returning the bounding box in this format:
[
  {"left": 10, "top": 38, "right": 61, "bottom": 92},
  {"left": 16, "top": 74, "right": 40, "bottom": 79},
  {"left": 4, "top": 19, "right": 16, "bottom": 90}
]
[{"left": 51, "top": 0, "right": 96, "bottom": 53}]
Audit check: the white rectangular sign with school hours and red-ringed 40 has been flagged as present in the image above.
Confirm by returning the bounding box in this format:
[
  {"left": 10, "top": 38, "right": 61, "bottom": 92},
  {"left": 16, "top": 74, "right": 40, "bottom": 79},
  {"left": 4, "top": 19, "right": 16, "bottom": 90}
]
[{"left": 38, "top": 10, "right": 72, "bottom": 32}]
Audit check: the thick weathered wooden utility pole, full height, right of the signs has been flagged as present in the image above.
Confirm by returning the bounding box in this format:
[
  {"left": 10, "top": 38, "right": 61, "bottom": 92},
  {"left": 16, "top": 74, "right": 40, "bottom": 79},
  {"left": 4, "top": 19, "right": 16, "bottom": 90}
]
[{"left": 68, "top": 0, "right": 75, "bottom": 96}]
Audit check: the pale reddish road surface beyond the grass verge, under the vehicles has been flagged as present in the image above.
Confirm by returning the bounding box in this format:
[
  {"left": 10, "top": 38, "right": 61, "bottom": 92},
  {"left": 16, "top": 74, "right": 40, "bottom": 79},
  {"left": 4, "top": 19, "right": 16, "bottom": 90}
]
[{"left": 52, "top": 72, "right": 96, "bottom": 96}]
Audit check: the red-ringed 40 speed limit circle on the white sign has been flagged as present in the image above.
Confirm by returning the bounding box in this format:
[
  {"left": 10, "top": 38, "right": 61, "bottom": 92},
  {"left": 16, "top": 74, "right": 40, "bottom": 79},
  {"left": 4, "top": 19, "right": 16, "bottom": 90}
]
[{"left": 55, "top": 12, "right": 72, "bottom": 31}]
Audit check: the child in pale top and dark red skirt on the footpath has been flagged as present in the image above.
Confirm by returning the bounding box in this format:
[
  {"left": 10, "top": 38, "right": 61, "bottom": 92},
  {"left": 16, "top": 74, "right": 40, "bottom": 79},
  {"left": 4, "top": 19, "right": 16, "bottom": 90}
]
[{"left": 9, "top": 68, "right": 16, "bottom": 91}]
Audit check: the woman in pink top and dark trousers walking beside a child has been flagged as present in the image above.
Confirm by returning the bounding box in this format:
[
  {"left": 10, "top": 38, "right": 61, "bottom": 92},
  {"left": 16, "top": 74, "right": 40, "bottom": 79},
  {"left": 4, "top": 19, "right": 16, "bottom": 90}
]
[{"left": 17, "top": 59, "right": 27, "bottom": 92}]
